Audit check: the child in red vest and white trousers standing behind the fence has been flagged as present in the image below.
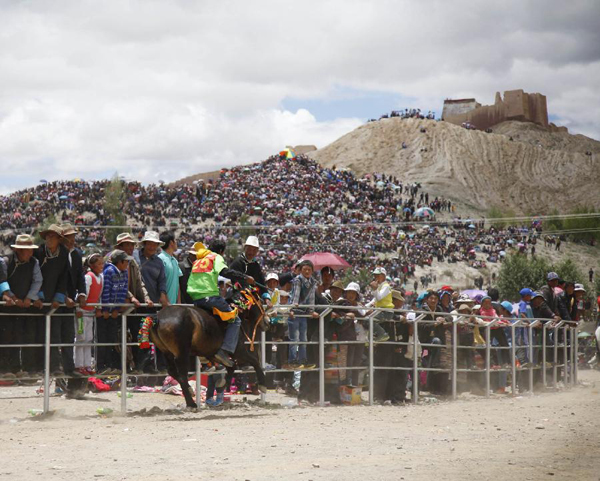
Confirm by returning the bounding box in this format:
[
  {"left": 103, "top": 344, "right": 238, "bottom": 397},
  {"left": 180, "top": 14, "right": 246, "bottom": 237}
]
[{"left": 75, "top": 254, "right": 104, "bottom": 375}]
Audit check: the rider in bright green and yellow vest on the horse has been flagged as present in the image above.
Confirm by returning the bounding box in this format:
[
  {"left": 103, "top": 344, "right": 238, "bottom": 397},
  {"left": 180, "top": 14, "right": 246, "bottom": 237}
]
[{"left": 187, "top": 241, "right": 254, "bottom": 367}]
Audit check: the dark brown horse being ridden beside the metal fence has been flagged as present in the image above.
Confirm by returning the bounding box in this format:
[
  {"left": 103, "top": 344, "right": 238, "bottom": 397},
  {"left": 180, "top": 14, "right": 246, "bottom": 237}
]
[{"left": 149, "top": 290, "right": 269, "bottom": 408}]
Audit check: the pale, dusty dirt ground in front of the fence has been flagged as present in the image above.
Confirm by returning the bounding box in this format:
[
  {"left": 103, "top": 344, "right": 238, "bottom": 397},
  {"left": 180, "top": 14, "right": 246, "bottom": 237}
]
[{"left": 0, "top": 371, "right": 600, "bottom": 480}]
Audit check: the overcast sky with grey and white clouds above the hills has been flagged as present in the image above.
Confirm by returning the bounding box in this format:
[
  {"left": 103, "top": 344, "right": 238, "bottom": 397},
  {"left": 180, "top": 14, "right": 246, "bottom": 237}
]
[{"left": 0, "top": 0, "right": 600, "bottom": 193}]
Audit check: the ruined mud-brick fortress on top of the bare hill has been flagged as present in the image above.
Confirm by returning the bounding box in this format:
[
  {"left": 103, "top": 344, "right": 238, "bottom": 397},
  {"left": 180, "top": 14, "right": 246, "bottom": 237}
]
[{"left": 442, "top": 90, "right": 567, "bottom": 132}]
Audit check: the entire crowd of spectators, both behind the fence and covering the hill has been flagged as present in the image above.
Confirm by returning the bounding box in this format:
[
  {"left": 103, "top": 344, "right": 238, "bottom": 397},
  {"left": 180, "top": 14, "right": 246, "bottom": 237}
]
[{"left": 0, "top": 151, "right": 583, "bottom": 402}]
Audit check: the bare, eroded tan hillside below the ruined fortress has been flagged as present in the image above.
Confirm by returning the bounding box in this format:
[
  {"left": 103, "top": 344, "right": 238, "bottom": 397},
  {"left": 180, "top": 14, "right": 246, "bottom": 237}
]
[{"left": 308, "top": 118, "right": 600, "bottom": 214}]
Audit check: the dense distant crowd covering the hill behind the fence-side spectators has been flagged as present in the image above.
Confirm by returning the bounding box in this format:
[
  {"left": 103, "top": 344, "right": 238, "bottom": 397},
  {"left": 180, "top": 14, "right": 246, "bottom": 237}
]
[{"left": 0, "top": 154, "right": 539, "bottom": 282}]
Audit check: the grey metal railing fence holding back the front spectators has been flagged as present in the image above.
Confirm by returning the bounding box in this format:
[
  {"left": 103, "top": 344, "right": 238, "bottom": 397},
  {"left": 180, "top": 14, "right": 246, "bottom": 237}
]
[{"left": 0, "top": 303, "right": 578, "bottom": 414}]
